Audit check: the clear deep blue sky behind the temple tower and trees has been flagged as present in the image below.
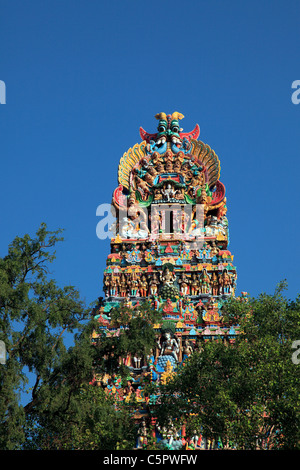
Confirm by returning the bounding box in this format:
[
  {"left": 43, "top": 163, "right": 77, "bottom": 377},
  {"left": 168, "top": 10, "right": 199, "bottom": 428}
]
[{"left": 0, "top": 0, "right": 300, "bottom": 302}]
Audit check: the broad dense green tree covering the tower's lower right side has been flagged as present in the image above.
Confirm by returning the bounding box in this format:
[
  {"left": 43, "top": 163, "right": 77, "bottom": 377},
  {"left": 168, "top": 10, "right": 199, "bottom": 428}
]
[{"left": 152, "top": 283, "right": 300, "bottom": 449}]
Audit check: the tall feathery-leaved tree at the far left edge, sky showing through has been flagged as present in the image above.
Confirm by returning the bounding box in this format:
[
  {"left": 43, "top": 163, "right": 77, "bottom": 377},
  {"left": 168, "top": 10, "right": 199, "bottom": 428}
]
[{"left": 0, "top": 224, "right": 97, "bottom": 449}]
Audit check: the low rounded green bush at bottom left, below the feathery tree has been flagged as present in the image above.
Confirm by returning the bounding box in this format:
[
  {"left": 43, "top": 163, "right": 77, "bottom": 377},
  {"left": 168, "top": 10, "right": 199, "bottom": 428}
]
[{"left": 25, "top": 384, "right": 135, "bottom": 450}]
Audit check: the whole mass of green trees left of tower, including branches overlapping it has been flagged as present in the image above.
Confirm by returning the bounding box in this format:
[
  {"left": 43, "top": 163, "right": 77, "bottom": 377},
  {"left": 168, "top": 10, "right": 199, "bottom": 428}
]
[{"left": 0, "top": 224, "right": 162, "bottom": 450}]
